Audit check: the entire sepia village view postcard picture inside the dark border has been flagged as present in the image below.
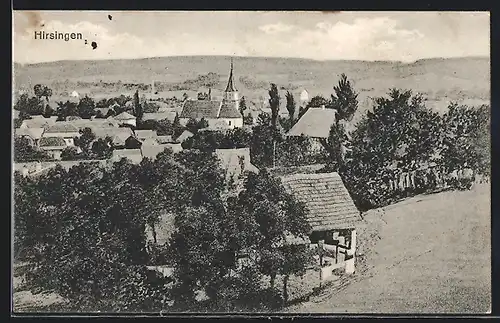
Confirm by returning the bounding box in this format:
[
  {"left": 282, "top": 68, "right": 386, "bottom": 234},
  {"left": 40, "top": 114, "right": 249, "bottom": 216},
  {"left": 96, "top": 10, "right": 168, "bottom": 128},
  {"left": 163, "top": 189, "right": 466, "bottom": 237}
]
[{"left": 11, "top": 10, "right": 492, "bottom": 316}]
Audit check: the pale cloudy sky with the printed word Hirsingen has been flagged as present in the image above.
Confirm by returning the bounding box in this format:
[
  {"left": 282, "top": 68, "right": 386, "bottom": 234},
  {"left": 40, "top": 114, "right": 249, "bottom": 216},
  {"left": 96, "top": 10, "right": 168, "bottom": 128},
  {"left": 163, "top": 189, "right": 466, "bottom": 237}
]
[{"left": 13, "top": 11, "right": 490, "bottom": 64}]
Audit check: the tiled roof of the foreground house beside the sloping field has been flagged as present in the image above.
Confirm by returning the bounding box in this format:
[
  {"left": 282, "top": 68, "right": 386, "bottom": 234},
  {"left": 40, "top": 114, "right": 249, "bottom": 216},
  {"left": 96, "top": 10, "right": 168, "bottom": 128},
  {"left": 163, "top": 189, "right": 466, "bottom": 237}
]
[{"left": 281, "top": 173, "right": 361, "bottom": 231}]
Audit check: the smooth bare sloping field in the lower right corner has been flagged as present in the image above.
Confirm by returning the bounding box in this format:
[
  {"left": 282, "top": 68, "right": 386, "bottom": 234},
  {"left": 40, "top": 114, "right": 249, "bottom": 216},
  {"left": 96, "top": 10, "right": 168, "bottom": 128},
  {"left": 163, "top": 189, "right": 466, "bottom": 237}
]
[{"left": 289, "top": 186, "right": 491, "bottom": 313}]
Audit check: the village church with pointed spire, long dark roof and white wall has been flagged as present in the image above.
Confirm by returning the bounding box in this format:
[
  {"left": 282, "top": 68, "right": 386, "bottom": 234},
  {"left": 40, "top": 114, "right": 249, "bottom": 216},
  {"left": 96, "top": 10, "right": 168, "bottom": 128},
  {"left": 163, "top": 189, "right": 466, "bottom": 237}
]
[{"left": 179, "top": 60, "right": 243, "bottom": 129}]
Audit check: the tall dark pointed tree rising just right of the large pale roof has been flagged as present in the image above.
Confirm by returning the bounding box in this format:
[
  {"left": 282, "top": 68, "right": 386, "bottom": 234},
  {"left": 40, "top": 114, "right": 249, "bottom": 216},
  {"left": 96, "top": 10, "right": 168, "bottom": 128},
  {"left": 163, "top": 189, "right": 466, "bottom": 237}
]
[{"left": 331, "top": 74, "right": 358, "bottom": 121}]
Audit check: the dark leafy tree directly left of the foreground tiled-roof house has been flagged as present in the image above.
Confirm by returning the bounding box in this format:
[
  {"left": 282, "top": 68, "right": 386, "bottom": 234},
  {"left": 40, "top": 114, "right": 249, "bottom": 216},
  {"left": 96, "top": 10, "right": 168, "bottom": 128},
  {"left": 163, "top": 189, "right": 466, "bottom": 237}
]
[{"left": 238, "top": 170, "right": 312, "bottom": 296}]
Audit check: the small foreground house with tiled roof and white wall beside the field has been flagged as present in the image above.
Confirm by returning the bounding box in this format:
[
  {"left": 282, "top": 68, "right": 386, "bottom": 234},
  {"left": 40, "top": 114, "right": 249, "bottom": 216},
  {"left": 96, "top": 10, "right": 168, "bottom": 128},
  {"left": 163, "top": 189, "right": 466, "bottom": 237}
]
[{"left": 280, "top": 173, "right": 362, "bottom": 274}]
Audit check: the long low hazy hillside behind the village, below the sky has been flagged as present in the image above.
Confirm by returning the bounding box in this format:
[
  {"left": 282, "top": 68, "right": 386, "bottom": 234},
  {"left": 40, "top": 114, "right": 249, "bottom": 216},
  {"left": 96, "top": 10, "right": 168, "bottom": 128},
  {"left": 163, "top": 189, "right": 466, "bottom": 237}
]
[{"left": 10, "top": 56, "right": 490, "bottom": 121}]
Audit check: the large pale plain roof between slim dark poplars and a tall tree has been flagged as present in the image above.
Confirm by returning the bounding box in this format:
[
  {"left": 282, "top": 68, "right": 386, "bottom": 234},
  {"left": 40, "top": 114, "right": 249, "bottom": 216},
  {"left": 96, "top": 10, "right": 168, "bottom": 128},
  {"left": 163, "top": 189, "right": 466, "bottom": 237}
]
[{"left": 287, "top": 108, "right": 336, "bottom": 138}]
